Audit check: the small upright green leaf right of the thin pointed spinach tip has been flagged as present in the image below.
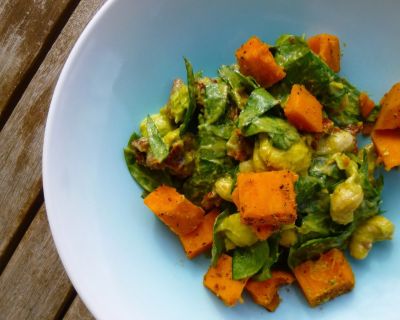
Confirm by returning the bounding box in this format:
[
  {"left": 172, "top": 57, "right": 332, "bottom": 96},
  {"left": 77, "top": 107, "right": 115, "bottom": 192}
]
[{"left": 204, "top": 82, "right": 228, "bottom": 124}]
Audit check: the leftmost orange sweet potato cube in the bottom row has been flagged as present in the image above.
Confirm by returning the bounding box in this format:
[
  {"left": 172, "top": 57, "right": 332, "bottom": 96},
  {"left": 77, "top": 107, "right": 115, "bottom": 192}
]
[{"left": 204, "top": 254, "right": 247, "bottom": 307}]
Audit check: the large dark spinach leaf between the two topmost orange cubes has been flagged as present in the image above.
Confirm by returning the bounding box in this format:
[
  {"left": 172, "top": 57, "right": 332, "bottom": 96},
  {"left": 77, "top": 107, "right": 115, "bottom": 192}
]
[{"left": 271, "top": 35, "right": 360, "bottom": 127}]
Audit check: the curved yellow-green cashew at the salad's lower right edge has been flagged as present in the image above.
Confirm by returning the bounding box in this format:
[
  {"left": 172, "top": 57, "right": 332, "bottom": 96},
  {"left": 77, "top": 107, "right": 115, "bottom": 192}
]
[{"left": 349, "top": 216, "right": 394, "bottom": 259}]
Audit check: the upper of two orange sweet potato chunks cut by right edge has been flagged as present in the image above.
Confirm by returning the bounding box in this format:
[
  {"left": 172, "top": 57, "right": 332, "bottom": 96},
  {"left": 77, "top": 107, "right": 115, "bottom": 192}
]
[{"left": 374, "top": 82, "right": 400, "bottom": 130}]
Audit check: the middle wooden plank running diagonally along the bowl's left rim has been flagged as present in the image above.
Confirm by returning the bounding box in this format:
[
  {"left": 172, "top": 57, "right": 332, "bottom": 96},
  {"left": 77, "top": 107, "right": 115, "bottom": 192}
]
[{"left": 0, "top": 0, "right": 104, "bottom": 272}]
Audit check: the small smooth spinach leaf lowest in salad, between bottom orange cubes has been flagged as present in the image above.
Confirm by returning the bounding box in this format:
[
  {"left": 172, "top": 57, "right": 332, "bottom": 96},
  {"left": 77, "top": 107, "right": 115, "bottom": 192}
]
[{"left": 232, "top": 241, "right": 269, "bottom": 280}]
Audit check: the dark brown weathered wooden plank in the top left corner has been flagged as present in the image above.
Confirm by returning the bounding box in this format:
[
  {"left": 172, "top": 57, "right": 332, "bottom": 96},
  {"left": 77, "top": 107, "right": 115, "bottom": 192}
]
[{"left": 0, "top": 0, "right": 77, "bottom": 124}]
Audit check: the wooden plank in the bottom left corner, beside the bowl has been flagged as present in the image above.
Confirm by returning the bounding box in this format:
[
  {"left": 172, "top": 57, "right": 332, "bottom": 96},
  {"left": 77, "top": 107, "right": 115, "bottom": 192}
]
[{"left": 0, "top": 207, "right": 74, "bottom": 320}]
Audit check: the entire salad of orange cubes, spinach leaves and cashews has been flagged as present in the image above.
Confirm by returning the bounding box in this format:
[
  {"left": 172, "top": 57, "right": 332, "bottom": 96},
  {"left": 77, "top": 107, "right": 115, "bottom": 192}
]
[{"left": 124, "top": 34, "right": 400, "bottom": 311}]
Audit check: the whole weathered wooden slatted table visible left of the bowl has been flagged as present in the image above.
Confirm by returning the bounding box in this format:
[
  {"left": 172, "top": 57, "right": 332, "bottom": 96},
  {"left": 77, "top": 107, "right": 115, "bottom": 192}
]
[{"left": 0, "top": 0, "right": 105, "bottom": 320}]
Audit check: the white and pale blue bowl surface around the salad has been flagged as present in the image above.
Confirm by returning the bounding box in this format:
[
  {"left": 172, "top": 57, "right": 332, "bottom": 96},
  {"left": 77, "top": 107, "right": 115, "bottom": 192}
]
[{"left": 43, "top": 0, "right": 400, "bottom": 319}]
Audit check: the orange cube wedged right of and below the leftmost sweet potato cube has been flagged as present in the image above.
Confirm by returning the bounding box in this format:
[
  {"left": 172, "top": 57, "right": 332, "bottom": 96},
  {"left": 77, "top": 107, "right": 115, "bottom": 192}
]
[{"left": 179, "top": 210, "right": 219, "bottom": 259}]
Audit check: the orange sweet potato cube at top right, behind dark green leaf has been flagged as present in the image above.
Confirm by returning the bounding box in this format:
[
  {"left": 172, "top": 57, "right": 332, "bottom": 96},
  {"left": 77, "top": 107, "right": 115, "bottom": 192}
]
[{"left": 307, "top": 33, "right": 340, "bottom": 72}]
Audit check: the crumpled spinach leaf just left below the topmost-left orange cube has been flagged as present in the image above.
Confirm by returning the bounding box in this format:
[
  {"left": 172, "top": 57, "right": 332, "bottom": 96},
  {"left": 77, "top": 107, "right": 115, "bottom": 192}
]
[{"left": 218, "top": 65, "right": 259, "bottom": 109}]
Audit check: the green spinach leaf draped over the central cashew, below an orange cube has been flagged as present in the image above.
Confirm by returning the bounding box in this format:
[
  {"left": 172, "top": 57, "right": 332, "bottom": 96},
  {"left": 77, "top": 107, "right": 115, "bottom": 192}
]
[{"left": 243, "top": 116, "right": 300, "bottom": 150}]
